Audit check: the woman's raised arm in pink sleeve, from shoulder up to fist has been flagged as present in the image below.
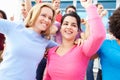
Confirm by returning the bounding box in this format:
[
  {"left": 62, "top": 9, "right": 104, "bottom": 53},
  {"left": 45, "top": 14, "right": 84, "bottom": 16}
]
[{"left": 80, "top": 0, "right": 106, "bottom": 57}]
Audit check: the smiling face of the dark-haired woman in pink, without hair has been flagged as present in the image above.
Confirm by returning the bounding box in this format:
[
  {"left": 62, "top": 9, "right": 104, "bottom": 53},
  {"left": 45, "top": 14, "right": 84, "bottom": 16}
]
[{"left": 61, "top": 16, "right": 78, "bottom": 41}]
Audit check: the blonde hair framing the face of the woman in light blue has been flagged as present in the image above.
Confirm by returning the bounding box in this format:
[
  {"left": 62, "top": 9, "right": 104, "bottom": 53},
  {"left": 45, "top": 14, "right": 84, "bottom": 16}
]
[{"left": 25, "top": 3, "right": 55, "bottom": 37}]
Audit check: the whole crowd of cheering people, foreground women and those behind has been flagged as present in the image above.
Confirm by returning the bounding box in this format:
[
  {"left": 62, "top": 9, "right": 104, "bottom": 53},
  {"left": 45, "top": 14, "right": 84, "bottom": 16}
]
[{"left": 0, "top": 0, "right": 120, "bottom": 80}]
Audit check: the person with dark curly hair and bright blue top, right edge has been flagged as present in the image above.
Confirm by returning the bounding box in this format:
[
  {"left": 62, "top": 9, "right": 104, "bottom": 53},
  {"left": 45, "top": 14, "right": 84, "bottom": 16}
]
[{"left": 98, "top": 7, "right": 120, "bottom": 80}]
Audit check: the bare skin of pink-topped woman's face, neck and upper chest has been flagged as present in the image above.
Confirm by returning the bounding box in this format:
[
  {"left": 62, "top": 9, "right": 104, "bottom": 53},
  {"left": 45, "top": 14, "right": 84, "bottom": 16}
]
[{"left": 56, "top": 16, "right": 78, "bottom": 56}]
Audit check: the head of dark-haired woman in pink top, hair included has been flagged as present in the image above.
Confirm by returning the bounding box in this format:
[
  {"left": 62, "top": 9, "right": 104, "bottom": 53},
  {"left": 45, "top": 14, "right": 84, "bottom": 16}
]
[{"left": 60, "top": 12, "right": 81, "bottom": 40}]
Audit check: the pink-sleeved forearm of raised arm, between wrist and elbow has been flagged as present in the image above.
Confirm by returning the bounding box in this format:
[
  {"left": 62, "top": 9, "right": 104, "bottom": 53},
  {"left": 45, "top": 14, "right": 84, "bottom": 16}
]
[{"left": 86, "top": 5, "right": 106, "bottom": 39}]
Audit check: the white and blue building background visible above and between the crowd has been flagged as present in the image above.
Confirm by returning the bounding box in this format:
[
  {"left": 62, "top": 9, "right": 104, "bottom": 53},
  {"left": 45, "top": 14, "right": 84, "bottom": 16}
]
[{"left": 0, "top": 0, "right": 120, "bottom": 20}]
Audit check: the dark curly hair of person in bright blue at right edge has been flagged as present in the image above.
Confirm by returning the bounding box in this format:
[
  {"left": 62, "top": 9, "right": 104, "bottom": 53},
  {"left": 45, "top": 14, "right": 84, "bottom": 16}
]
[{"left": 109, "top": 7, "right": 120, "bottom": 39}]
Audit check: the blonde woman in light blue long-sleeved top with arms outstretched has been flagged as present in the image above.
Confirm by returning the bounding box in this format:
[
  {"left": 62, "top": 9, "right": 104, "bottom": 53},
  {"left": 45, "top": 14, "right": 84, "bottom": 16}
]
[{"left": 0, "top": 3, "right": 57, "bottom": 80}]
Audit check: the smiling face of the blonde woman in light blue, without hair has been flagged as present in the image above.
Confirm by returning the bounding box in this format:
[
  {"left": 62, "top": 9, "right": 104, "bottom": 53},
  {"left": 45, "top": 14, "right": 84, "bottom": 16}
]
[{"left": 33, "top": 7, "right": 53, "bottom": 33}]
